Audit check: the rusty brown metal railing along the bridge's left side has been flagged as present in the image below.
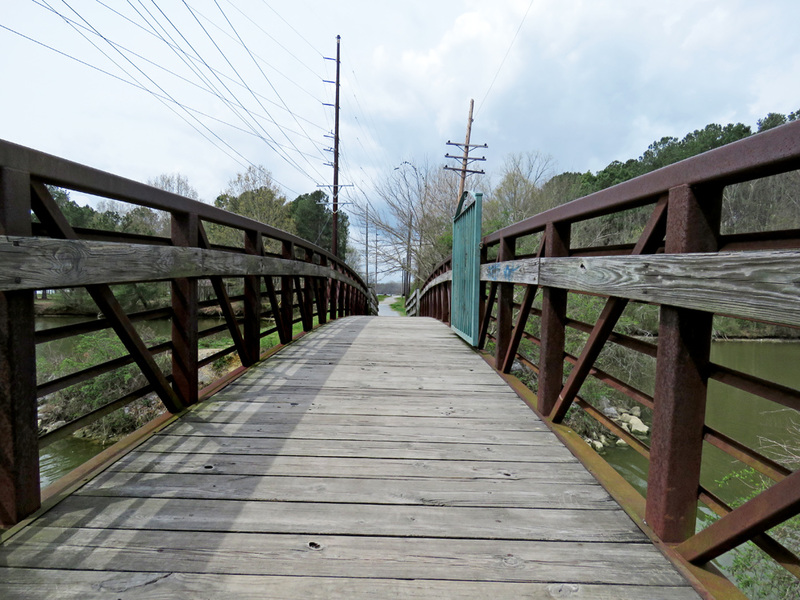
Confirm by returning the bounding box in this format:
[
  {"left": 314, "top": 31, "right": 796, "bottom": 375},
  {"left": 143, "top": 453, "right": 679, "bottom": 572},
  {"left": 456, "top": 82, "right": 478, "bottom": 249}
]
[{"left": 0, "top": 141, "right": 377, "bottom": 527}]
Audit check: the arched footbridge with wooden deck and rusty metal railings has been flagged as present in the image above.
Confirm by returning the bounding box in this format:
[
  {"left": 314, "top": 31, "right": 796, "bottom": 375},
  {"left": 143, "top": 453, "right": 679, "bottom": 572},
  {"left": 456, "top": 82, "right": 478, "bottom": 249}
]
[{"left": 0, "top": 124, "right": 800, "bottom": 600}]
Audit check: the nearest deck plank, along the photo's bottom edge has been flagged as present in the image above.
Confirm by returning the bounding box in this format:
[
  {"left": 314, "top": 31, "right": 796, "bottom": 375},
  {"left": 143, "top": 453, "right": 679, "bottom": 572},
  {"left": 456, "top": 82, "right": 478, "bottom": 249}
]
[{"left": 4, "top": 569, "right": 708, "bottom": 600}]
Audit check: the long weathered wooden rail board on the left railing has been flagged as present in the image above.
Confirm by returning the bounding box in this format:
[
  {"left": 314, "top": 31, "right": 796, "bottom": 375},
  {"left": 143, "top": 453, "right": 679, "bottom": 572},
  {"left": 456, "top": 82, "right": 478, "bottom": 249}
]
[{"left": 0, "top": 236, "right": 366, "bottom": 293}]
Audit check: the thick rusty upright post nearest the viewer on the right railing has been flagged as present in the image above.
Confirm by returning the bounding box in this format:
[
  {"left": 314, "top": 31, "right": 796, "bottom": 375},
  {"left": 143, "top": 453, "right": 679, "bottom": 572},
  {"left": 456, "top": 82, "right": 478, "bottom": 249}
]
[{"left": 646, "top": 185, "right": 722, "bottom": 543}]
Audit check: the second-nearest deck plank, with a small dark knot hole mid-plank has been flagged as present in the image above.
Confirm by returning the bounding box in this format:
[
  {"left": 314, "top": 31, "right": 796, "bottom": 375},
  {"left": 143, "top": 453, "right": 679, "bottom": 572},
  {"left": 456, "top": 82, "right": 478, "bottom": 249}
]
[{"left": 3, "top": 527, "right": 683, "bottom": 586}]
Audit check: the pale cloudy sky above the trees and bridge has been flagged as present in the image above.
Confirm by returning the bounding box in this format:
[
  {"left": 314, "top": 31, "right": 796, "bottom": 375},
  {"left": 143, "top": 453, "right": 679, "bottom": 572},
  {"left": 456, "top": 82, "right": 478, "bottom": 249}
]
[{"left": 0, "top": 0, "right": 800, "bottom": 213}]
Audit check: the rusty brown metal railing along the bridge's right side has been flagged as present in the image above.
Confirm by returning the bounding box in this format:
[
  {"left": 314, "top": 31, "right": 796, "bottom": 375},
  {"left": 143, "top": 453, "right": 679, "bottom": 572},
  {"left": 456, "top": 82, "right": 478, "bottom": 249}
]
[{"left": 419, "top": 122, "right": 800, "bottom": 588}]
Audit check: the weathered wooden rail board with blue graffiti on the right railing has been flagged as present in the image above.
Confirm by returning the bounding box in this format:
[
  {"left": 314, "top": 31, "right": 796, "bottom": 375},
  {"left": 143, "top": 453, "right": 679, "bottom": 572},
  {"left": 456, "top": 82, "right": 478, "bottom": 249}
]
[{"left": 481, "top": 250, "right": 800, "bottom": 325}]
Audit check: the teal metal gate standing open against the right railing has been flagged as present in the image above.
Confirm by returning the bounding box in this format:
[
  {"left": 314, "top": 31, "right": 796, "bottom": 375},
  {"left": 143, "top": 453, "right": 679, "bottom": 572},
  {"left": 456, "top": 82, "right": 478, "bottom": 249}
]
[{"left": 450, "top": 192, "right": 483, "bottom": 346}]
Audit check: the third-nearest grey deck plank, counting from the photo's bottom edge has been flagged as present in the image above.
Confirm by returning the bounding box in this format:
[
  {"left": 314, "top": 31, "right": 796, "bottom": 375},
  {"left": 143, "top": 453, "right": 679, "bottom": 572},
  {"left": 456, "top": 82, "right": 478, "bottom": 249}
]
[{"left": 29, "top": 496, "right": 642, "bottom": 543}]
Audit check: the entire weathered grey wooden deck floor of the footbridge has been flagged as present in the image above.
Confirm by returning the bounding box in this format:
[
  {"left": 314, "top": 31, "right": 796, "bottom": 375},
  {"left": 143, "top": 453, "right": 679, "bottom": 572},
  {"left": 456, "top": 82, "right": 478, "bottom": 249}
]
[{"left": 0, "top": 317, "right": 697, "bottom": 600}]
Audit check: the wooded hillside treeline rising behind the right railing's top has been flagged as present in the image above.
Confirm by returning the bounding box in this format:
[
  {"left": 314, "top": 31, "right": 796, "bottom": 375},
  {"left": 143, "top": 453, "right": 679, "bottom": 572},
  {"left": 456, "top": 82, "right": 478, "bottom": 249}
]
[{"left": 484, "top": 111, "right": 800, "bottom": 246}]
